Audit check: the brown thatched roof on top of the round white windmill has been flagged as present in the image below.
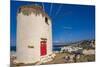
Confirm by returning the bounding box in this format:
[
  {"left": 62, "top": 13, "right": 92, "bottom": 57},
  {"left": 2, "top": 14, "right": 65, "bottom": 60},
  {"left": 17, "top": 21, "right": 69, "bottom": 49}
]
[{"left": 18, "top": 5, "right": 50, "bottom": 18}]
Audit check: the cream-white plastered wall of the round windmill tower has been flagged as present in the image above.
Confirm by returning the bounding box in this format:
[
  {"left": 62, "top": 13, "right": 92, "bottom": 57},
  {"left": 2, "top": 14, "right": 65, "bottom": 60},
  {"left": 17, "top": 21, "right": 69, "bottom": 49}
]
[{"left": 16, "top": 13, "right": 52, "bottom": 63}]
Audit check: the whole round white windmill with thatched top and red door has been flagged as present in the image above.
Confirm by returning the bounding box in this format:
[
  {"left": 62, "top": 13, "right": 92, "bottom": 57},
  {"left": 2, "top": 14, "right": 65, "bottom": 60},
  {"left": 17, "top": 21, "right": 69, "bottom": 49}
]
[{"left": 17, "top": 5, "right": 52, "bottom": 64}]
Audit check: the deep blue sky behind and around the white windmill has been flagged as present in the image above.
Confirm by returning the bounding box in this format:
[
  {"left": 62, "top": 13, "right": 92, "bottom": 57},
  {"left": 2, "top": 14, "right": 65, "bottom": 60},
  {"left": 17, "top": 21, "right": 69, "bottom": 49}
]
[{"left": 11, "top": 1, "right": 95, "bottom": 45}]
